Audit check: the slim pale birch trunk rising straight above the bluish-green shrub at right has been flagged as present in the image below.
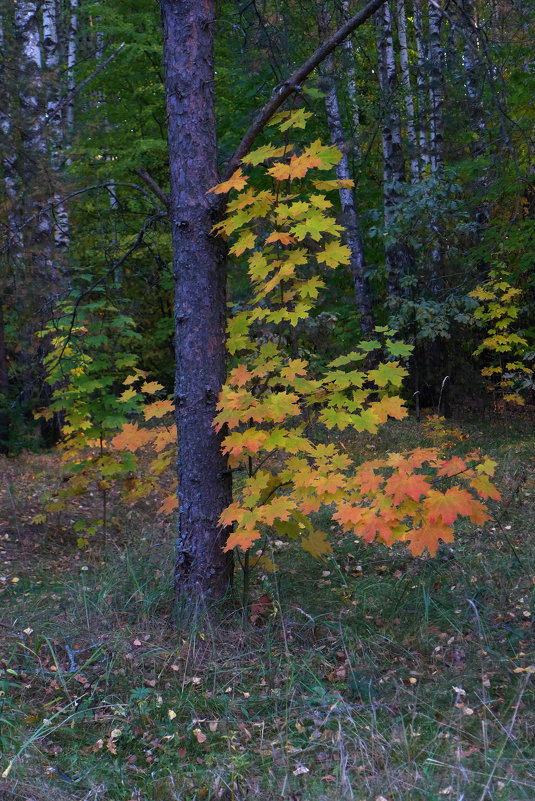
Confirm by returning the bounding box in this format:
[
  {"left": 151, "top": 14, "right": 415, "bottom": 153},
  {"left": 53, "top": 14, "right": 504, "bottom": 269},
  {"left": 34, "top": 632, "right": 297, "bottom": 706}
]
[{"left": 428, "top": 0, "right": 444, "bottom": 172}]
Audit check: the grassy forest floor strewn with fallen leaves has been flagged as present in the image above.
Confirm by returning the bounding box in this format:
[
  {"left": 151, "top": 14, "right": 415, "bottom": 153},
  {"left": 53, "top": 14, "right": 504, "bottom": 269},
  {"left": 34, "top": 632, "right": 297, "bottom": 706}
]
[{"left": 0, "top": 419, "right": 535, "bottom": 801}]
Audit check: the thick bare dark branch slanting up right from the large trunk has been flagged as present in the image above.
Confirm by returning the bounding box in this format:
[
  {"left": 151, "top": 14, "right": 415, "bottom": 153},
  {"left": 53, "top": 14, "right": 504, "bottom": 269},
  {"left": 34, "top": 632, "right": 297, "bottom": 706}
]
[{"left": 221, "top": 0, "right": 385, "bottom": 183}]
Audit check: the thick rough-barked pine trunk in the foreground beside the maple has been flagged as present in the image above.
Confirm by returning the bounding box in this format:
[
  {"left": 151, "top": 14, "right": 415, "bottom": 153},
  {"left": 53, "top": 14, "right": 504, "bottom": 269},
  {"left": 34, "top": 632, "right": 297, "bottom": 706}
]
[{"left": 161, "top": 0, "right": 232, "bottom": 602}]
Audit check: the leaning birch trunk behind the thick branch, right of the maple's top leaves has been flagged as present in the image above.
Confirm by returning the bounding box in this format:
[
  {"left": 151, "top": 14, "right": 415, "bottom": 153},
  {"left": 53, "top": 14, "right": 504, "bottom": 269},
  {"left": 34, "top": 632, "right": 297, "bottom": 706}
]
[{"left": 318, "top": 3, "right": 373, "bottom": 333}]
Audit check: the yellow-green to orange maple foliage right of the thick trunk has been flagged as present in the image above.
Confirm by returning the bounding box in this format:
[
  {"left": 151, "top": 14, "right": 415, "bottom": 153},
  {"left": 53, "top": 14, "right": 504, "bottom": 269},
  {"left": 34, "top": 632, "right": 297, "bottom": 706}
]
[{"left": 207, "top": 115, "right": 499, "bottom": 557}]
